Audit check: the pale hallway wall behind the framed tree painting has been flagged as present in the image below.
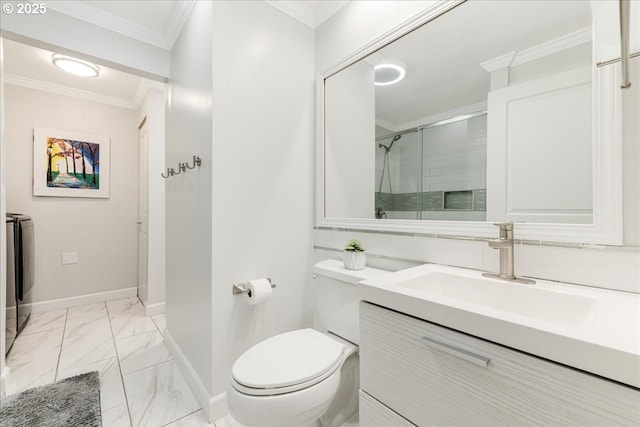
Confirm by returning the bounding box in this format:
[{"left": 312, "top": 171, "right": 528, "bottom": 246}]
[{"left": 3, "top": 85, "right": 138, "bottom": 303}]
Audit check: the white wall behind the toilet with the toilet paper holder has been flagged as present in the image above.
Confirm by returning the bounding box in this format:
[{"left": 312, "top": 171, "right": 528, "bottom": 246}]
[{"left": 211, "top": 1, "right": 315, "bottom": 400}]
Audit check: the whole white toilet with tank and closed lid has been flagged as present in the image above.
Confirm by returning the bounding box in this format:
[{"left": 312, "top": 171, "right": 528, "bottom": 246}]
[{"left": 227, "top": 260, "right": 388, "bottom": 427}]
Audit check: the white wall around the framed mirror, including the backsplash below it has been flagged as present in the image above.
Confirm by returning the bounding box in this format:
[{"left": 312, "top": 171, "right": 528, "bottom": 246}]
[{"left": 314, "top": 1, "right": 640, "bottom": 292}]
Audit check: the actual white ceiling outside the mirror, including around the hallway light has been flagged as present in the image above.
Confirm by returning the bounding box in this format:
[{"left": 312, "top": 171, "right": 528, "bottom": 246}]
[{"left": 4, "top": 0, "right": 347, "bottom": 108}]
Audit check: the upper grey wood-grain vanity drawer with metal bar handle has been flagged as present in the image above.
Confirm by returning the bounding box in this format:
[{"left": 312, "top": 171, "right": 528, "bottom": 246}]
[{"left": 360, "top": 302, "right": 640, "bottom": 427}]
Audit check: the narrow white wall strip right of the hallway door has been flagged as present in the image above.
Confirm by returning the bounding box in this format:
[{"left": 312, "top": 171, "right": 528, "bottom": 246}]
[{"left": 138, "top": 87, "right": 166, "bottom": 315}]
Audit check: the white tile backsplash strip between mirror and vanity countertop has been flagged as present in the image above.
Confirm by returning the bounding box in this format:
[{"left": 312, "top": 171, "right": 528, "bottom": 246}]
[{"left": 314, "top": 228, "right": 640, "bottom": 293}]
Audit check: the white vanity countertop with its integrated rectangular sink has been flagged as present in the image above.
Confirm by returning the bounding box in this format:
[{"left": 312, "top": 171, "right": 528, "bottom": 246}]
[{"left": 358, "top": 264, "right": 640, "bottom": 388}]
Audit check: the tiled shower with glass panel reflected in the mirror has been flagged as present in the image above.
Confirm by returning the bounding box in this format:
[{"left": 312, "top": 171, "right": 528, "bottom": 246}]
[{"left": 376, "top": 115, "right": 487, "bottom": 221}]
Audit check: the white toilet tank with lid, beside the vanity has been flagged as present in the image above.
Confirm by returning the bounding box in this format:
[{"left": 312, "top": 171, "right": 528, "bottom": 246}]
[{"left": 313, "top": 259, "right": 389, "bottom": 344}]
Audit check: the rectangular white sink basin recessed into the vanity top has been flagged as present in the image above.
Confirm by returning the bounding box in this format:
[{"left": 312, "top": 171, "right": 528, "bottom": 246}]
[{"left": 397, "top": 271, "right": 596, "bottom": 327}]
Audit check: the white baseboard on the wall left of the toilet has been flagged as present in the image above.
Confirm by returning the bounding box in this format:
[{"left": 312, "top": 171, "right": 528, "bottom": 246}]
[{"left": 164, "top": 330, "right": 229, "bottom": 423}]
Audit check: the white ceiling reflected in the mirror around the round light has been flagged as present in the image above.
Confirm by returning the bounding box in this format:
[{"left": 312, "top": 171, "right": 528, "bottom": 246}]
[{"left": 367, "top": 0, "right": 591, "bottom": 131}]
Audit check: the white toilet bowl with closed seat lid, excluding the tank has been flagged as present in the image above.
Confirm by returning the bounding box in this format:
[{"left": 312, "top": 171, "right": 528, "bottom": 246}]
[{"left": 227, "top": 329, "right": 357, "bottom": 427}]
